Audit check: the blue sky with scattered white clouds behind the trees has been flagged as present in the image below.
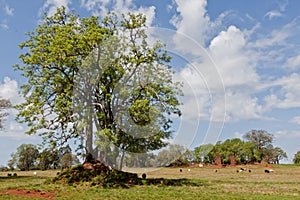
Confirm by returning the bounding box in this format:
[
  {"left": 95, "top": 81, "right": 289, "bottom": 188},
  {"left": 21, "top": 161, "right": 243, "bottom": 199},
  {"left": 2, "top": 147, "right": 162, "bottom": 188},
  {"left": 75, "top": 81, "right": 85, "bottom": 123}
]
[{"left": 0, "top": 0, "right": 300, "bottom": 166}]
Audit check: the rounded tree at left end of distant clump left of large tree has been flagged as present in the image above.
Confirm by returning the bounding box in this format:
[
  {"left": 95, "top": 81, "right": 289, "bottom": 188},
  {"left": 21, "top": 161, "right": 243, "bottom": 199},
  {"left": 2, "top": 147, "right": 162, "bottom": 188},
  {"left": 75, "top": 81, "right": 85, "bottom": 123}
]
[{"left": 9, "top": 144, "right": 39, "bottom": 171}]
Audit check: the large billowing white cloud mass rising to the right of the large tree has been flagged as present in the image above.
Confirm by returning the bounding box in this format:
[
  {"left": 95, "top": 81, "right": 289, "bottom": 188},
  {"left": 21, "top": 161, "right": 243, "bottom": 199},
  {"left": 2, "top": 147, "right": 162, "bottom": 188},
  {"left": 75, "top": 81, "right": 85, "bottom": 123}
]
[{"left": 171, "top": 0, "right": 263, "bottom": 121}]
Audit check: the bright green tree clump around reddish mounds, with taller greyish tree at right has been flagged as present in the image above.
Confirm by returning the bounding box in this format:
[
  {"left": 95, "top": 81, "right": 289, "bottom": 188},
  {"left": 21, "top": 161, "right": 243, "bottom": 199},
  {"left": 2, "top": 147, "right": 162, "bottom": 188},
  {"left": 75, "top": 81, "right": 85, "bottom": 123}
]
[{"left": 194, "top": 130, "right": 287, "bottom": 164}]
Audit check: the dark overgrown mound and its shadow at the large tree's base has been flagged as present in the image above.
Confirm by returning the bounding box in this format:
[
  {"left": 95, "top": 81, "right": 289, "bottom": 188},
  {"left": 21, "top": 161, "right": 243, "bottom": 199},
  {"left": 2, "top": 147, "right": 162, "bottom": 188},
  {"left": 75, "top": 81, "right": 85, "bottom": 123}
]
[{"left": 46, "top": 163, "right": 209, "bottom": 188}]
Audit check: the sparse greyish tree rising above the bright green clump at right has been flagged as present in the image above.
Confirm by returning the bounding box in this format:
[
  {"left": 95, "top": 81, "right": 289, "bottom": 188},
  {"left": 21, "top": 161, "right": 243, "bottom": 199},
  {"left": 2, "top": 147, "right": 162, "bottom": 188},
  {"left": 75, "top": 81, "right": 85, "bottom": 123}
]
[{"left": 244, "top": 130, "right": 273, "bottom": 162}]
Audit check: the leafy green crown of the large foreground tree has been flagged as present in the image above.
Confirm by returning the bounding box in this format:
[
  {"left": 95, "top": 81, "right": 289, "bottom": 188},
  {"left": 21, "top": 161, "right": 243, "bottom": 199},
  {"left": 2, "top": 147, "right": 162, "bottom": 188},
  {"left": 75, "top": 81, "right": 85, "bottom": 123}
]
[{"left": 16, "top": 8, "right": 181, "bottom": 167}]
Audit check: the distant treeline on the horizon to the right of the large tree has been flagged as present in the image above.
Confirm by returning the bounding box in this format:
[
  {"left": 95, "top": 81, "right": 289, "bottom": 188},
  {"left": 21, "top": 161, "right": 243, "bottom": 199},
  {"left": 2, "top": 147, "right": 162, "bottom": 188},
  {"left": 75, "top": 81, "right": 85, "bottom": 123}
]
[{"left": 125, "top": 130, "right": 290, "bottom": 167}]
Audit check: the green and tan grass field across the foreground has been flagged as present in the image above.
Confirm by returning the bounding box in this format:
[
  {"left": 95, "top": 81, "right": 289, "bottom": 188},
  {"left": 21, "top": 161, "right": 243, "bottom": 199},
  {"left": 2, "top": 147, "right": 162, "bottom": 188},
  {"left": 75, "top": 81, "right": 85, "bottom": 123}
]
[{"left": 0, "top": 165, "right": 300, "bottom": 200}]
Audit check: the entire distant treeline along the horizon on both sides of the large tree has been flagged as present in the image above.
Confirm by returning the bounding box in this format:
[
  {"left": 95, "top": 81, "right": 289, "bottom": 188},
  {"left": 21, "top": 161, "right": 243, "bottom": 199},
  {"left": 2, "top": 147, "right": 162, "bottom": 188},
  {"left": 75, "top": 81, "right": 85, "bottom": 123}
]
[{"left": 4, "top": 130, "right": 300, "bottom": 170}]
